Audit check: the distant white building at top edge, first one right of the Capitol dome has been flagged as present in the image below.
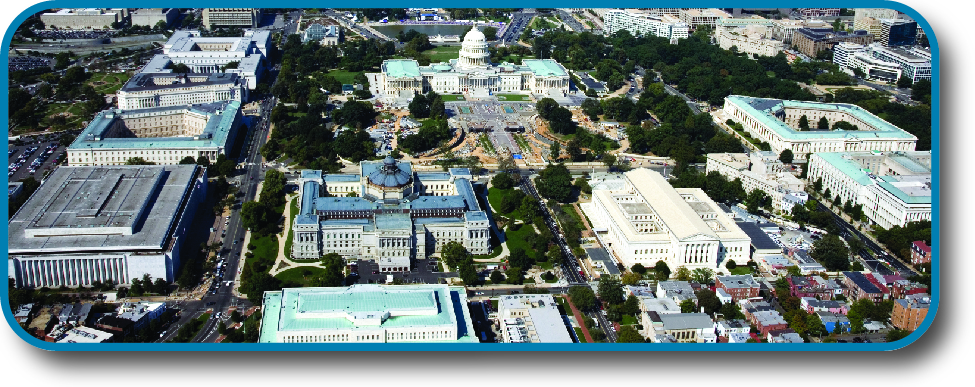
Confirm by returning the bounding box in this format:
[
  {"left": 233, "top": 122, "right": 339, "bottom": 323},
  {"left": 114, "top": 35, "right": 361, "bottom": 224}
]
[{"left": 603, "top": 8, "right": 690, "bottom": 43}]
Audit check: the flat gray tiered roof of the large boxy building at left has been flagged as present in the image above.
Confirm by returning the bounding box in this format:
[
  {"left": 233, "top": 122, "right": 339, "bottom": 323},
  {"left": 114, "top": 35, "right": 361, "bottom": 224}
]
[{"left": 8, "top": 165, "right": 196, "bottom": 254}]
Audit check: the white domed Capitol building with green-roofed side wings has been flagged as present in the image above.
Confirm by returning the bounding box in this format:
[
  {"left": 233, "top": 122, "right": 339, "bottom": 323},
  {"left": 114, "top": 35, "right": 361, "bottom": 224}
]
[{"left": 381, "top": 28, "right": 569, "bottom": 97}]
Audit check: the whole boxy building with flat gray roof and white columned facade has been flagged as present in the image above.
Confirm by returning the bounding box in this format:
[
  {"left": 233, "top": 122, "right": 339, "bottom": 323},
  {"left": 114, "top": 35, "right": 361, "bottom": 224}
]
[{"left": 7, "top": 165, "right": 206, "bottom": 288}]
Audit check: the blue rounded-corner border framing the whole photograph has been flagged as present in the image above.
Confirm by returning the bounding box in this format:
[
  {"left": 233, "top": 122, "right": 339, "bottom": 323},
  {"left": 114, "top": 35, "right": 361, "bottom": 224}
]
[{"left": 0, "top": 0, "right": 941, "bottom": 352}]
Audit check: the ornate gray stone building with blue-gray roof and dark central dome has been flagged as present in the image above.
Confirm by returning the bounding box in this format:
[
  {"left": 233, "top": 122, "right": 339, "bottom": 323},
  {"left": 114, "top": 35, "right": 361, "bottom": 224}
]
[{"left": 291, "top": 157, "right": 491, "bottom": 272}]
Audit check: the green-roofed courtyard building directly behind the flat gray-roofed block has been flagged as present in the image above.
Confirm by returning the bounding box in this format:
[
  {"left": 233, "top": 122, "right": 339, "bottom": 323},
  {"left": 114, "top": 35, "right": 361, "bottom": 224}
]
[{"left": 67, "top": 101, "right": 243, "bottom": 166}]
